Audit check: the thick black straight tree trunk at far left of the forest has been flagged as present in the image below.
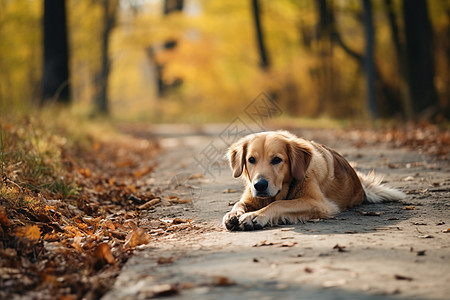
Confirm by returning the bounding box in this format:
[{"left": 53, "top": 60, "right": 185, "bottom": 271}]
[{"left": 41, "top": 0, "right": 70, "bottom": 104}]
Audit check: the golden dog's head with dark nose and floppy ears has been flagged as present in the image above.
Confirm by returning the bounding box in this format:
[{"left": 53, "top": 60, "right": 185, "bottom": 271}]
[{"left": 228, "top": 131, "right": 311, "bottom": 198}]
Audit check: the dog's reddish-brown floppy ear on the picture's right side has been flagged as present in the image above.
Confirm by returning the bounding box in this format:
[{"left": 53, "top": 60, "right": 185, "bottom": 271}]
[{"left": 287, "top": 140, "right": 312, "bottom": 181}]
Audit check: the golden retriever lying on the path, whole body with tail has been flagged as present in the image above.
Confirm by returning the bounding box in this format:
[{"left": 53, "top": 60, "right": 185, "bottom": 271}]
[{"left": 223, "top": 131, "right": 405, "bottom": 230}]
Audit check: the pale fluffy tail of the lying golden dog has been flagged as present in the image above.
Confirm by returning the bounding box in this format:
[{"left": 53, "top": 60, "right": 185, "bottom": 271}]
[{"left": 357, "top": 170, "right": 406, "bottom": 203}]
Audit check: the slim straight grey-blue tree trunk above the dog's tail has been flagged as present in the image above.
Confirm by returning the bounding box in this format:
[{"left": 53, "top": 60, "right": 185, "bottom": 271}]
[{"left": 363, "top": 0, "right": 378, "bottom": 118}]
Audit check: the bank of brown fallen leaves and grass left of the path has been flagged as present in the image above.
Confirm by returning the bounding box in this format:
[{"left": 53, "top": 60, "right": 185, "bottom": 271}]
[{"left": 0, "top": 124, "right": 193, "bottom": 299}]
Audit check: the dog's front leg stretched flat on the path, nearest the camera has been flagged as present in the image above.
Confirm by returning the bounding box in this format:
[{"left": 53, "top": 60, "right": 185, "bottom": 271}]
[{"left": 239, "top": 198, "right": 339, "bottom": 230}]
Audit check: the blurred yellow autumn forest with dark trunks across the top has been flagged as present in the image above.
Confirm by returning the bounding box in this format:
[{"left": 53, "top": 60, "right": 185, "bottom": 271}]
[{"left": 0, "top": 0, "right": 450, "bottom": 122}]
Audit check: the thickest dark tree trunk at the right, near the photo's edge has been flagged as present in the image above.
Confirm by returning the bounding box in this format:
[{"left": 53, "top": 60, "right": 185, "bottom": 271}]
[{"left": 403, "top": 0, "right": 438, "bottom": 117}]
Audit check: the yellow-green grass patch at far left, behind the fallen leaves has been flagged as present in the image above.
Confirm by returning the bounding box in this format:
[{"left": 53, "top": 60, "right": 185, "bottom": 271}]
[{"left": 0, "top": 107, "right": 93, "bottom": 205}]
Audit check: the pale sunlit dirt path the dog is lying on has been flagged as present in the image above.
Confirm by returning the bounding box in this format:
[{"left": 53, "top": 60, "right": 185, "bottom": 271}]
[{"left": 104, "top": 125, "right": 450, "bottom": 300}]
